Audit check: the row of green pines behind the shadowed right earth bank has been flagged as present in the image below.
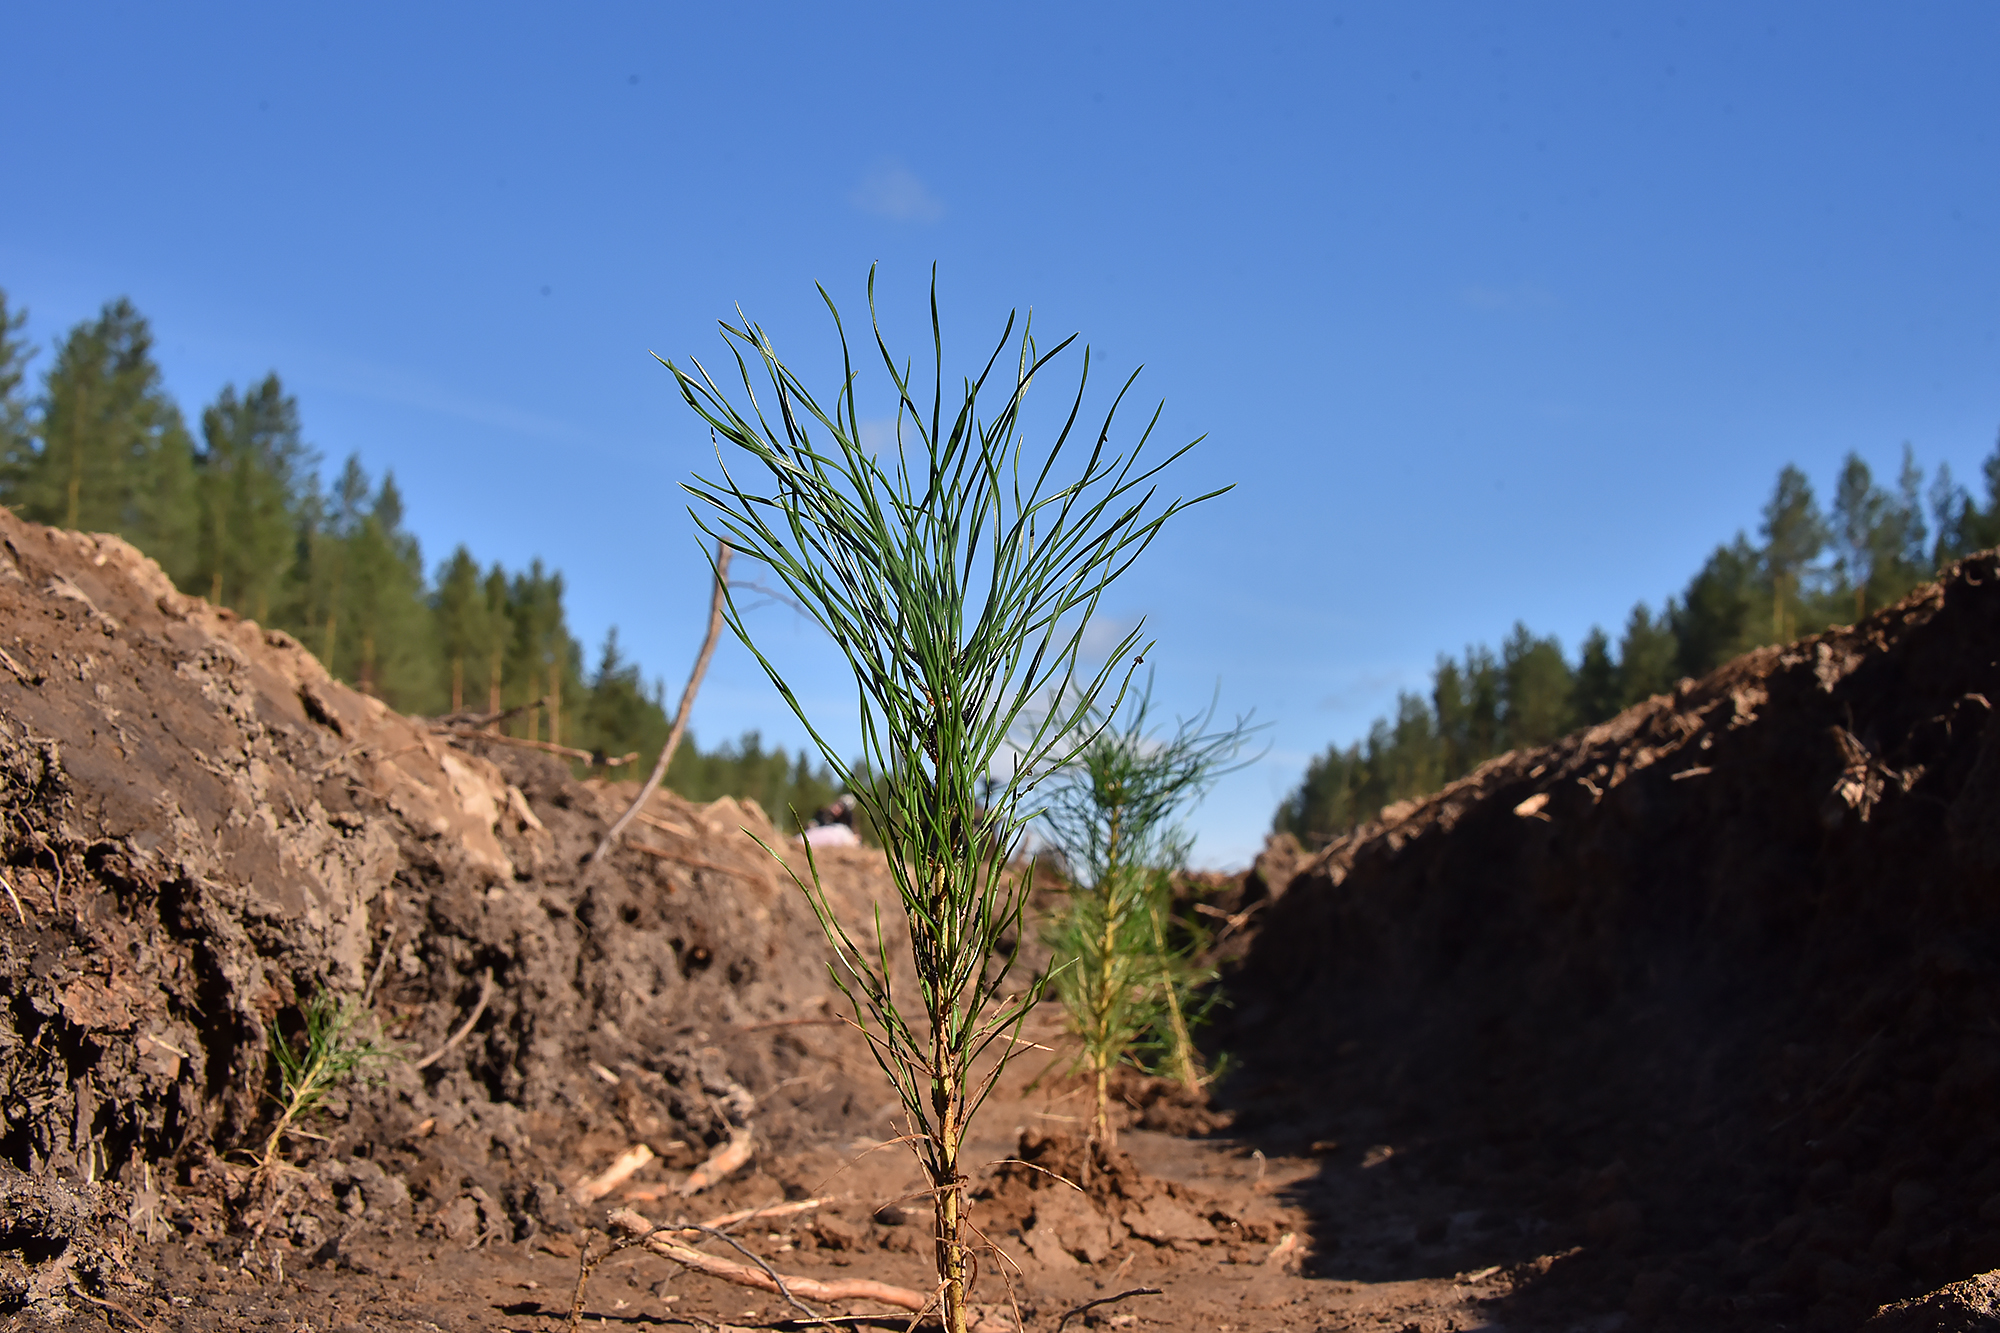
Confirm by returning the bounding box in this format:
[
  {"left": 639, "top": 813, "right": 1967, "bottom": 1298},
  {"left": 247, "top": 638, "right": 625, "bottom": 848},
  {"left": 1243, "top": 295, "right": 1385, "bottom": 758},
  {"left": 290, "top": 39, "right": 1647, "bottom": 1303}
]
[{"left": 1272, "top": 446, "right": 2000, "bottom": 845}]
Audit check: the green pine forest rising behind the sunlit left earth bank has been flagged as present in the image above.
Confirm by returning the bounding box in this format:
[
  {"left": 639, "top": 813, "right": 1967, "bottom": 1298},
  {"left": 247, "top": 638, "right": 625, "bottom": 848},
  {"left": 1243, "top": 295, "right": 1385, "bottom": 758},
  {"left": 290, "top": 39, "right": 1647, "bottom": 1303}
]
[{"left": 0, "top": 292, "right": 838, "bottom": 825}]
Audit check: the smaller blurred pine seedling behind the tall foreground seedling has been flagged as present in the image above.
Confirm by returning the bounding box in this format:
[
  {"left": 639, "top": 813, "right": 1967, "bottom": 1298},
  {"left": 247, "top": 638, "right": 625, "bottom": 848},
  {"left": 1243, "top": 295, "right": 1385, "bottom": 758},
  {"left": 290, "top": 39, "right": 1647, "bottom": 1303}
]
[{"left": 1042, "top": 681, "right": 1252, "bottom": 1147}]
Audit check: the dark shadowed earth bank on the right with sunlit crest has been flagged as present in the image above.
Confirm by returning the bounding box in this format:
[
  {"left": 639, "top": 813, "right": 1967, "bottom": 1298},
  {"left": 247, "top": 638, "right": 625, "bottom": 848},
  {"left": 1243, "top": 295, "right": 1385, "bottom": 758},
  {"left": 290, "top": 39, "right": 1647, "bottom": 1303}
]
[{"left": 1222, "top": 554, "right": 2000, "bottom": 1329}]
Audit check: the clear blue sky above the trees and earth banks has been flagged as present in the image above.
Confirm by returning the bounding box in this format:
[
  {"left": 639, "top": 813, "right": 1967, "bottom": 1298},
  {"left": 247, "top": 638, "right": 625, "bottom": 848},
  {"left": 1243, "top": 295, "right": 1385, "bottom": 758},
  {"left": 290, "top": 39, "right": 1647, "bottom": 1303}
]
[{"left": 0, "top": 4, "right": 2000, "bottom": 865}]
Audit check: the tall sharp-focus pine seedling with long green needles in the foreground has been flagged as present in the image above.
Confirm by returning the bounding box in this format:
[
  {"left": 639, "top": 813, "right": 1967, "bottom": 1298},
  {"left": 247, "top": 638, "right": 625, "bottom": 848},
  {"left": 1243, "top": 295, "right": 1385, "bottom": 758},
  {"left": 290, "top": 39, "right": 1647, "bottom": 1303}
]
[{"left": 664, "top": 272, "right": 1220, "bottom": 1333}]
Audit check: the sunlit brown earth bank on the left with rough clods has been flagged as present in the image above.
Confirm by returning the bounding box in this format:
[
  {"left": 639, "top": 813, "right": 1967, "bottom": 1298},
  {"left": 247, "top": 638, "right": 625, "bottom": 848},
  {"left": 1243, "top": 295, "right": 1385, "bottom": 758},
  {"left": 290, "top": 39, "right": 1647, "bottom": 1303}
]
[{"left": 0, "top": 510, "right": 888, "bottom": 1313}]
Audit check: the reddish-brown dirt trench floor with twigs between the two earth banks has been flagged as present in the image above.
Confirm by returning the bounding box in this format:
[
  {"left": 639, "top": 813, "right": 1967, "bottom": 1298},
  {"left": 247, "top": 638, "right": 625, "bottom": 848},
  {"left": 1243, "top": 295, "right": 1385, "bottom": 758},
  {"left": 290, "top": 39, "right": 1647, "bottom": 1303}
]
[{"left": 125, "top": 1011, "right": 1534, "bottom": 1333}]
